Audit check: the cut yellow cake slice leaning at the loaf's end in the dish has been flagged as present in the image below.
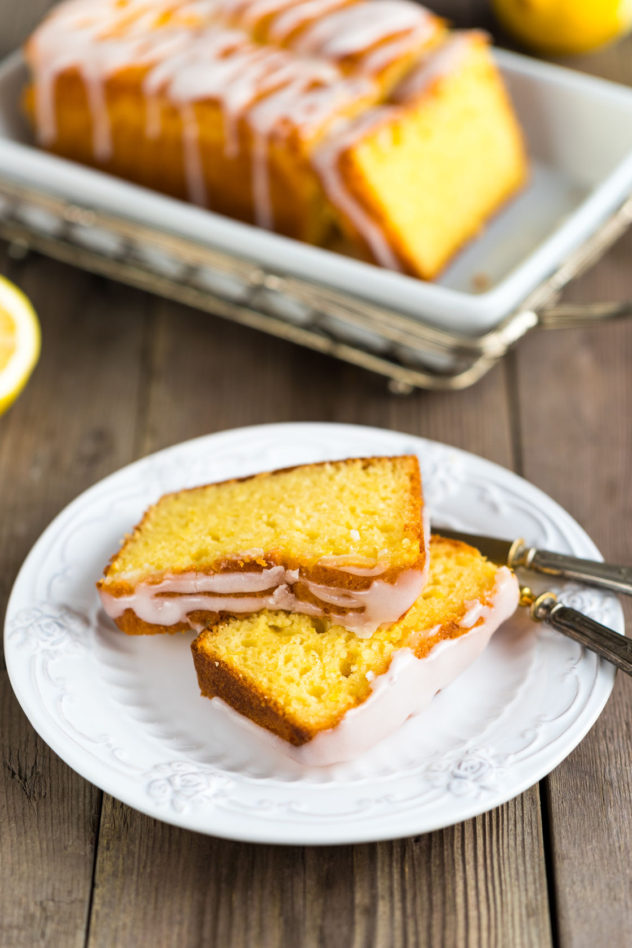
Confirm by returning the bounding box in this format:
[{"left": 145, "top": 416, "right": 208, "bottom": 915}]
[{"left": 313, "top": 31, "right": 527, "bottom": 279}]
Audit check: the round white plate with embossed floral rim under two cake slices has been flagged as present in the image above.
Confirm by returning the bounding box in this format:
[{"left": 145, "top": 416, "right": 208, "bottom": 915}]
[{"left": 5, "top": 424, "right": 623, "bottom": 844}]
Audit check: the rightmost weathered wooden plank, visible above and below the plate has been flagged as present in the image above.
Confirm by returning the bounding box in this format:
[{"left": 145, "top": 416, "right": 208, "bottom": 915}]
[{"left": 515, "top": 31, "right": 632, "bottom": 946}]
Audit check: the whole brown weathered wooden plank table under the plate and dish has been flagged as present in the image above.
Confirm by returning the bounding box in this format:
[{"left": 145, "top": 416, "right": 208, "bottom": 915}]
[{"left": 0, "top": 0, "right": 632, "bottom": 948}]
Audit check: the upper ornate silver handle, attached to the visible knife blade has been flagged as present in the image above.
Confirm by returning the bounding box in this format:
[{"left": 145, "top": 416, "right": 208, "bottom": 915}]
[{"left": 509, "top": 540, "right": 632, "bottom": 596}]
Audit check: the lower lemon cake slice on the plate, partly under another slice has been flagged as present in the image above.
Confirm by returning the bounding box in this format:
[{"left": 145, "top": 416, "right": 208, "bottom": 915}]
[{"left": 192, "top": 536, "right": 518, "bottom": 765}]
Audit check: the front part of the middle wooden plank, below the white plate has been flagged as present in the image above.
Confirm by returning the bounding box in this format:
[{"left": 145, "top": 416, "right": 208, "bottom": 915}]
[{"left": 90, "top": 790, "right": 549, "bottom": 948}]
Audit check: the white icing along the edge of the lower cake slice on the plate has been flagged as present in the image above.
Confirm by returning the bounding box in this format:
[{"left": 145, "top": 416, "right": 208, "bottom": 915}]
[{"left": 213, "top": 567, "right": 519, "bottom": 767}]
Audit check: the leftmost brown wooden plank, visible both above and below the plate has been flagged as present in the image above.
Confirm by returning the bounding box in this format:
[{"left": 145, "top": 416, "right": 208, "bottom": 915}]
[{"left": 0, "top": 253, "right": 152, "bottom": 948}]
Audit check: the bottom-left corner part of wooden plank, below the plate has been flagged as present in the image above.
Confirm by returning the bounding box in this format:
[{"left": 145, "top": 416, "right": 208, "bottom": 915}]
[{"left": 0, "top": 670, "right": 100, "bottom": 948}]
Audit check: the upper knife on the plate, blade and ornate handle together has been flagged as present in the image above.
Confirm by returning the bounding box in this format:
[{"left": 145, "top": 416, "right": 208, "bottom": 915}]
[{"left": 432, "top": 524, "right": 632, "bottom": 596}]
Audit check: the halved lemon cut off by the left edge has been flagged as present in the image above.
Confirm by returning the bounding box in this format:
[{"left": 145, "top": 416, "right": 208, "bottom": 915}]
[{"left": 0, "top": 276, "right": 40, "bottom": 414}]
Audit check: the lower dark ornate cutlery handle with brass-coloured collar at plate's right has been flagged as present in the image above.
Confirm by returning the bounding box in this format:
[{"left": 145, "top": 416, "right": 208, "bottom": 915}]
[{"left": 520, "top": 587, "right": 632, "bottom": 675}]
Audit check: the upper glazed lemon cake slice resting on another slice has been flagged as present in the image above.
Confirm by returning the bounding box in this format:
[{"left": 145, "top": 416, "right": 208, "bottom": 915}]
[{"left": 98, "top": 455, "right": 427, "bottom": 636}]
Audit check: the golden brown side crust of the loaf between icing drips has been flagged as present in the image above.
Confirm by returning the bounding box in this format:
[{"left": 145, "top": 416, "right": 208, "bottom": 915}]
[{"left": 23, "top": 67, "right": 330, "bottom": 244}]
